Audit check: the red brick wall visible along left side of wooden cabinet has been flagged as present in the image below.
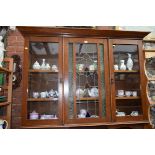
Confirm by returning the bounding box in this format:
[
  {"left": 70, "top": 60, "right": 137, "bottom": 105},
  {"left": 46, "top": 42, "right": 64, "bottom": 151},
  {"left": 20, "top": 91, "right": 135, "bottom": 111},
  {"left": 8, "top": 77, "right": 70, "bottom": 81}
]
[{"left": 6, "top": 30, "right": 24, "bottom": 128}]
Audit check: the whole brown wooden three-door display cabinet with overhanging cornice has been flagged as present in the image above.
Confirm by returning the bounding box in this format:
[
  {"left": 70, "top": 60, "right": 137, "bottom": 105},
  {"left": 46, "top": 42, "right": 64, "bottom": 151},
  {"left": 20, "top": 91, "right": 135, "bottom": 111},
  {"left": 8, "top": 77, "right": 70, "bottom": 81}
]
[{"left": 17, "top": 27, "right": 148, "bottom": 128}]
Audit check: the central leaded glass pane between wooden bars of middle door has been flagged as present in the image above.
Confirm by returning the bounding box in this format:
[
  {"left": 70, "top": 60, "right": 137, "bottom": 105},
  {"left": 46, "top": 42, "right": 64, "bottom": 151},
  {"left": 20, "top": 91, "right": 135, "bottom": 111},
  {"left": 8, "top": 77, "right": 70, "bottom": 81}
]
[{"left": 75, "top": 43, "right": 99, "bottom": 118}]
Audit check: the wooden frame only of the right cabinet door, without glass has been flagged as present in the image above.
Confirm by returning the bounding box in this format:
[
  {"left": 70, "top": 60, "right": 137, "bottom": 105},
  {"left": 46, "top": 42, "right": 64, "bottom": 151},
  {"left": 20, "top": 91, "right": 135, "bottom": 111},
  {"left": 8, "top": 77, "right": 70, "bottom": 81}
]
[{"left": 109, "top": 39, "right": 147, "bottom": 122}]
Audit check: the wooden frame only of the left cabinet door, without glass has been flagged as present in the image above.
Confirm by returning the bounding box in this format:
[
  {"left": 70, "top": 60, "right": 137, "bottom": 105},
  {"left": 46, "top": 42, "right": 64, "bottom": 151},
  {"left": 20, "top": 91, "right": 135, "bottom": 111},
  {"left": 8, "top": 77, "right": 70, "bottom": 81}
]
[{"left": 22, "top": 36, "right": 63, "bottom": 128}]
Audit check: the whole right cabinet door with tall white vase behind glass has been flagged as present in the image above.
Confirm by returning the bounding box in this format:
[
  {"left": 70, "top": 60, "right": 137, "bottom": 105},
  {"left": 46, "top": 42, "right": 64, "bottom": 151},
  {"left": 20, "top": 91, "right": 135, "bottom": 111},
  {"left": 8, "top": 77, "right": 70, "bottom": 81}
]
[{"left": 109, "top": 39, "right": 146, "bottom": 122}]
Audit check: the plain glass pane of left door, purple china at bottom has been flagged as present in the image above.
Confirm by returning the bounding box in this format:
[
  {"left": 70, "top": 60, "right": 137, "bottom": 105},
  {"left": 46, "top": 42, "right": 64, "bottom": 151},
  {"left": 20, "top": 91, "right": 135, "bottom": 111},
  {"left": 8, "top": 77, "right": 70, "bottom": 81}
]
[{"left": 27, "top": 42, "right": 59, "bottom": 120}]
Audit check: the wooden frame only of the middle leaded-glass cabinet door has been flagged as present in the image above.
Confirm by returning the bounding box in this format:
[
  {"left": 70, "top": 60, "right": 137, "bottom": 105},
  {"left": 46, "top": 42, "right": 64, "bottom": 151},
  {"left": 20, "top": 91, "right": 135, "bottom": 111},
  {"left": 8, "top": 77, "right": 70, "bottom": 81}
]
[{"left": 64, "top": 38, "right": 111, "bottom": 125}]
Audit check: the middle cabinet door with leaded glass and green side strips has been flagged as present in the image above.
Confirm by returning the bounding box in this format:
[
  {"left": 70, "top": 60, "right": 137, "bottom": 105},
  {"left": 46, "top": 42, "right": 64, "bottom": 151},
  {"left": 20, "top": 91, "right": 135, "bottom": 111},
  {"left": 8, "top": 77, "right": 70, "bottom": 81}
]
[{"left": 64, "top": 38, "right": 110, "bottom": 124}]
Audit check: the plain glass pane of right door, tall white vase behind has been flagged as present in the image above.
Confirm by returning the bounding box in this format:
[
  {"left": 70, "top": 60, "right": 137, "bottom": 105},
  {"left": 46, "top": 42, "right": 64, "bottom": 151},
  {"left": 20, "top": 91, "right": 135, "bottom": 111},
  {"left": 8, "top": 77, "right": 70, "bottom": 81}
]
[{"left": 113, "top": 45, "right": 142, "bottom": 116}]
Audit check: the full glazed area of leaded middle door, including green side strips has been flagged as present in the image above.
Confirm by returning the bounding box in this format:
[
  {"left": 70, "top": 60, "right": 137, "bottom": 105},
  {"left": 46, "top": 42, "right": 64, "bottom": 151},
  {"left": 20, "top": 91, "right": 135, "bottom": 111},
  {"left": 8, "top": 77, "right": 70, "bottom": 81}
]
[{"left": 68, "top": 43, "right": 105, "bottom": 119}]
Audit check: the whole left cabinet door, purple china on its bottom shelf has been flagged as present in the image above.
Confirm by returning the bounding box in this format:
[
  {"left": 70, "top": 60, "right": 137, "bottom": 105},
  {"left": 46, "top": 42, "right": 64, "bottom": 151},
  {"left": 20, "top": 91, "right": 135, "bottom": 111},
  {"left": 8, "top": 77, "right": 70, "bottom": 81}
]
[{"left": 22, "top": 37, "right": 62, "bottom": 127}]
